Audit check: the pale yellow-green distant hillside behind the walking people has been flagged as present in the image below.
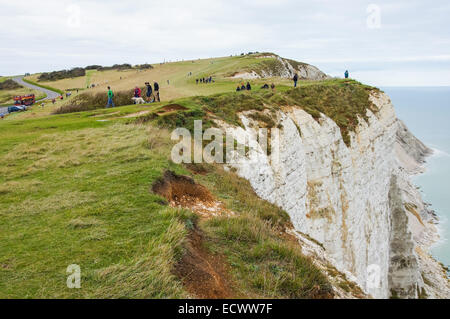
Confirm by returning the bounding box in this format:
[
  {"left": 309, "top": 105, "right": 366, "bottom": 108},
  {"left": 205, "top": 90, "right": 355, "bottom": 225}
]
[{"left": 27, "top": 55, "right": 298, "bottom": 101}]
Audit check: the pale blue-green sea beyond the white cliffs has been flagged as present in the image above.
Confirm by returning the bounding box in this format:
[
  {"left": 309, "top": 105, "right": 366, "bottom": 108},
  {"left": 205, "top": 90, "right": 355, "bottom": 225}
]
[{"left": 382, "top": 87, "right": 450, "bottom": 266}]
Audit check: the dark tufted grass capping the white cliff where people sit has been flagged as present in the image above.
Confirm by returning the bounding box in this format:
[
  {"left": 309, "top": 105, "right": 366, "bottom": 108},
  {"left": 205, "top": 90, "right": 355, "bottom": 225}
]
[{"left": 131, "top": 80, "right": 378, "bottom": 145}]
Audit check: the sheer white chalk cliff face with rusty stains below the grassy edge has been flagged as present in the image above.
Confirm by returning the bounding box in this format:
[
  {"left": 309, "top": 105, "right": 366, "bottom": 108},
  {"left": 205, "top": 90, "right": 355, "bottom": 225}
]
[{"left": 220, "top": 92, "right": 450, "bottom": 298}]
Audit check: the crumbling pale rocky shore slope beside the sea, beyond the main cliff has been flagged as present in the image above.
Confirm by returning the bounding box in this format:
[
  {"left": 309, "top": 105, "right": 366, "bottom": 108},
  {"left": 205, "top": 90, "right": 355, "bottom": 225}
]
[{"left": 395, "top": 120, "right": 450, "bottom": 299}]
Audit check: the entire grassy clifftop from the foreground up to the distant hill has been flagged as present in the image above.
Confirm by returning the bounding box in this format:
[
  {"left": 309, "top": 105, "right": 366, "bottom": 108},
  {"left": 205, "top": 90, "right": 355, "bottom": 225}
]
[{"left": 0, "top": 56, "right": 371, "bottom": 298}]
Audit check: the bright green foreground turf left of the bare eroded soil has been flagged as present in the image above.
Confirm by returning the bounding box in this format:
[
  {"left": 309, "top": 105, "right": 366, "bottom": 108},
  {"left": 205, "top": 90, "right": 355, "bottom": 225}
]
[{"left": 0, "top": 117, "right": 191, "bottom": 298}]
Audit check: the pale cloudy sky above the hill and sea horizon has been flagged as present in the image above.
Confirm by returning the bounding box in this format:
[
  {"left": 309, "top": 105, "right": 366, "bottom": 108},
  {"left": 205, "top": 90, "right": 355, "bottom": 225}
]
[{"left": 0, "top": 0, "right": 450, "bottom": 86}]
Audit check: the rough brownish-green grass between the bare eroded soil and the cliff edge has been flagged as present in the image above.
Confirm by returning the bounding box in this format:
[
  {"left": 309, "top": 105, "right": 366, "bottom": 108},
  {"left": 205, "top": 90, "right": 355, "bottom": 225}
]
[{"left": 192, "top": 166, "right": 331, "bottom": 298}]
